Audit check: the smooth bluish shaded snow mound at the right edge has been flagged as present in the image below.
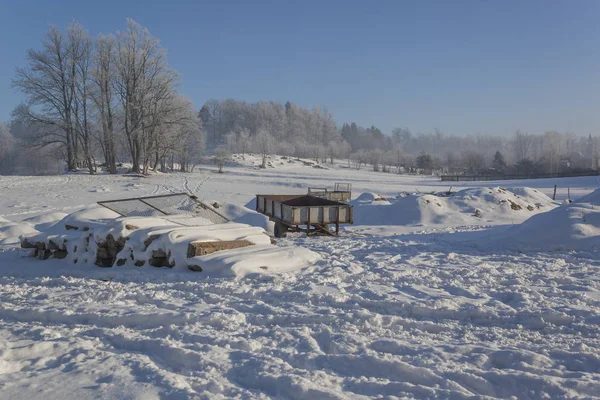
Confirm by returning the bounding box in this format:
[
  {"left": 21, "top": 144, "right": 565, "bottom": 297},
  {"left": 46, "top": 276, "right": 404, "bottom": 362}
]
[{"left": 486, "top": 189, "right": 600, "bottom": 251}]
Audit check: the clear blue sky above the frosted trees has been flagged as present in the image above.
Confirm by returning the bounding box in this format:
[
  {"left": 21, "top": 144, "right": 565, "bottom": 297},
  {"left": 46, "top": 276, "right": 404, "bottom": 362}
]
[{"left": 0, "top": 0, "right": 600, "bottom": 135}]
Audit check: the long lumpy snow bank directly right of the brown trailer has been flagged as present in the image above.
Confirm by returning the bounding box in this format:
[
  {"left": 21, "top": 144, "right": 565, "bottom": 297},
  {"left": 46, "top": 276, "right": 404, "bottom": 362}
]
[{"left": 352, "top": 187, "right": 557, "bottom": 226}]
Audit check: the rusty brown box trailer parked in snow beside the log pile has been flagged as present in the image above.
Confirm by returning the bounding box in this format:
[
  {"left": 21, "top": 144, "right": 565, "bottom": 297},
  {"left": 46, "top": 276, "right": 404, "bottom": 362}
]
[{"left": 256, "top": 194, "right": 354, "bottom": 237}]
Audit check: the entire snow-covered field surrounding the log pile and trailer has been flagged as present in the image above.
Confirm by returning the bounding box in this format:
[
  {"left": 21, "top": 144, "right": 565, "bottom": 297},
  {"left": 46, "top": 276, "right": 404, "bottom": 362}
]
[{"left": 0, "top": 157, "right": 600, "bottom": 400}]
